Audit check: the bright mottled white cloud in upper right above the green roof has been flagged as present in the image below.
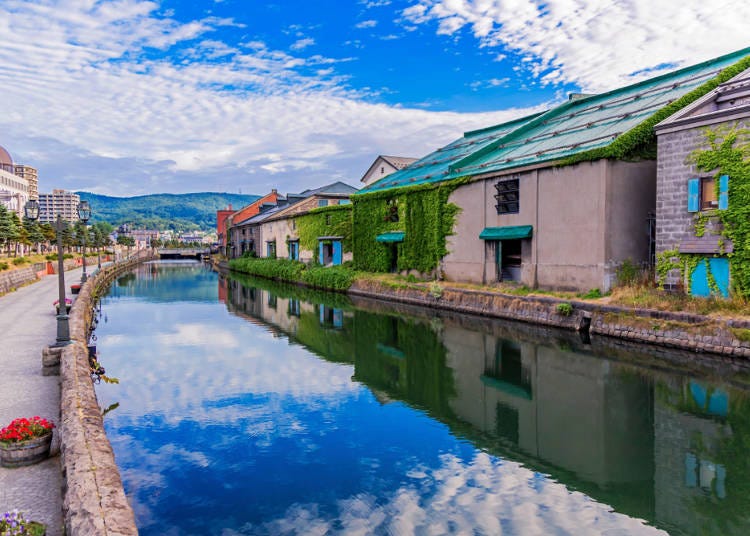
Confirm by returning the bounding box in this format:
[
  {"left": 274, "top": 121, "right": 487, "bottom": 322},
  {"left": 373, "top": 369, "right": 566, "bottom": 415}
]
[{"left": 402, "top": 0, "right": 750, "bottom": 91}]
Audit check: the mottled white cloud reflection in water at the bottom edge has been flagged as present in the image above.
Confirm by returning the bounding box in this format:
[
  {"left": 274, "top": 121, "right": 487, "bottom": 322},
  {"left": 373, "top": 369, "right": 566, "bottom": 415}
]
[{"left": 260, "top": 453, "right": 666, "bottom": 535}]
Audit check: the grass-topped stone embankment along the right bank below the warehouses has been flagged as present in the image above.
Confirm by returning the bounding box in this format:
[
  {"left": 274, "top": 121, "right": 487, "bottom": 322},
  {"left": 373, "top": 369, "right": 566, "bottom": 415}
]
[{"left": 349, "top": 280, "right": 750, "bottom": 358}]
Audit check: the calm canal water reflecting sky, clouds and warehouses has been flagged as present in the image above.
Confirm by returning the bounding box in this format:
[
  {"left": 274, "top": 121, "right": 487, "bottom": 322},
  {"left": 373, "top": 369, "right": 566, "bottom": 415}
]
[{"left": 94, "top": 262, "right": 750, "bottom": 535}]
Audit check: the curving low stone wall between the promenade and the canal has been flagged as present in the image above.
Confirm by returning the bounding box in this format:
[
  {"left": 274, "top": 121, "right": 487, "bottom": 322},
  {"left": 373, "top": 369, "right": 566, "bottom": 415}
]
[{"left": 60, "top": 252, "right": 152, "bottom": 536}]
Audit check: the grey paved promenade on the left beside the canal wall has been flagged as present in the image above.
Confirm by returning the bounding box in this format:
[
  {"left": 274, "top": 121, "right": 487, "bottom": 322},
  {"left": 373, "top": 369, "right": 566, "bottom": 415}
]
[{"left": 0, "top": 269, "right": 81, "bottom": 536}]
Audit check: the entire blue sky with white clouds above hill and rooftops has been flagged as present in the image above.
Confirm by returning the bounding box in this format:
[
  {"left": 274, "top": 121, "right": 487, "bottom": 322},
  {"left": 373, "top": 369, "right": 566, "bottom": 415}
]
[{"left": 0, "top": 0, "right": 750, "bottom": 196}]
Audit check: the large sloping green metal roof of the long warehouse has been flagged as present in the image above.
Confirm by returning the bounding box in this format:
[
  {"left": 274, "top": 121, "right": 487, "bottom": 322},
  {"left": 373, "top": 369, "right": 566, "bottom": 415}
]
[{"left": 359, "top": 48, "right": 750, "bottom": 193}]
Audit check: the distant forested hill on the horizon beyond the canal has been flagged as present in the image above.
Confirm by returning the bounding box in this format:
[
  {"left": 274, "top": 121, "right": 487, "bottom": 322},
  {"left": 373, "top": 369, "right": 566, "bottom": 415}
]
[{"left": 76, "top": 192, "right": 260, "bottom": 232}]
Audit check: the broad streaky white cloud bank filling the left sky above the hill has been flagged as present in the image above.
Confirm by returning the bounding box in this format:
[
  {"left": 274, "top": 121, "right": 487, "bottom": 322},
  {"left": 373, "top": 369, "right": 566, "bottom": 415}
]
[{"left": 0, "top": 0, "right": 540, "bottom": 195}]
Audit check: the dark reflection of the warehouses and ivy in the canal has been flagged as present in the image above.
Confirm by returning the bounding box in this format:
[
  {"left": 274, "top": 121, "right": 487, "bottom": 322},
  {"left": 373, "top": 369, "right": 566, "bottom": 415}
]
[{"left": 219, "top": 276, "right": 750, "bottom": 534}]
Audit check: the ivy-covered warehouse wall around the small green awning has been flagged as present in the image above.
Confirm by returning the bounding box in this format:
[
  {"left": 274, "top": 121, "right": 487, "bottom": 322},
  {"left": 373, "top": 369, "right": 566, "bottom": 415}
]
[{"left": 352, "top": 179, "right": 467, "bottom": 273}]
